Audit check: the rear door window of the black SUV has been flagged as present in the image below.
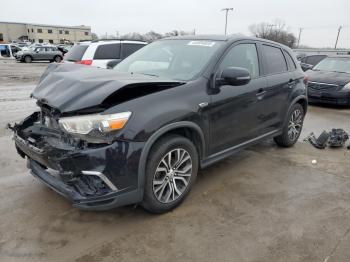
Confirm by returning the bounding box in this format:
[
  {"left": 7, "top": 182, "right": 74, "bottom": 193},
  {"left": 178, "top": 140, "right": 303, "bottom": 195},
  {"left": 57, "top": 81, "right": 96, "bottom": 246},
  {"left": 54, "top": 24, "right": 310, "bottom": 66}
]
[{"left": 263, "top": 45, "right": 287, "bottom": 74}]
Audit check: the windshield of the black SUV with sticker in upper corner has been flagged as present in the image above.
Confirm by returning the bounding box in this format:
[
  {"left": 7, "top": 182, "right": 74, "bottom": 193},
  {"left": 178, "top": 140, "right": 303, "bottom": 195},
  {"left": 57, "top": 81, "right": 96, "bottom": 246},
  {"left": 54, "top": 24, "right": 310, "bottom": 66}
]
[{"left": 114, "top": 40, "right": 221, "bottom": 81}]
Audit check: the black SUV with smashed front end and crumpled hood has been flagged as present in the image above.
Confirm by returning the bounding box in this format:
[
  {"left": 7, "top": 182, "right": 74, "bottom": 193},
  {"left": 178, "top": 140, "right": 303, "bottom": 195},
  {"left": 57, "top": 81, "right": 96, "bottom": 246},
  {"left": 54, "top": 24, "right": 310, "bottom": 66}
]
[{"left": 11, "top": 36, "right": 307, "bottom": 213}]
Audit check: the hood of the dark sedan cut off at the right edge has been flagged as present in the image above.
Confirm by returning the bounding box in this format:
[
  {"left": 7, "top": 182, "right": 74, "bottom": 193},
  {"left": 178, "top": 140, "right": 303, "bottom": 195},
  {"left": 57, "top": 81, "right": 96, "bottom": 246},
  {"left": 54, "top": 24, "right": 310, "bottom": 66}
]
[{"left": 305, "top": 70, "right": 350, "bottom": 86}]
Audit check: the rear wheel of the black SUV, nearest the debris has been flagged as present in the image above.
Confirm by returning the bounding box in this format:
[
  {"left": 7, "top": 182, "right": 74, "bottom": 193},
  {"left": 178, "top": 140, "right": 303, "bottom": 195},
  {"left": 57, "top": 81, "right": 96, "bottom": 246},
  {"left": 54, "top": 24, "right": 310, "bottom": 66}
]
[{"left": 274, "top": 103, "right": 305, "bottom": 147}]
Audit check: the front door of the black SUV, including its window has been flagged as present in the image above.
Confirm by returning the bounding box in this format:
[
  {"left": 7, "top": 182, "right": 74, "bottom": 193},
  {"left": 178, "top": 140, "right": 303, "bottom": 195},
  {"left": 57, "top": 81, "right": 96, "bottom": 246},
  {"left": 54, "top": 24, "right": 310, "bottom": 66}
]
[{"left": 209, "top": 41, "right": 267, "bottom": 154}]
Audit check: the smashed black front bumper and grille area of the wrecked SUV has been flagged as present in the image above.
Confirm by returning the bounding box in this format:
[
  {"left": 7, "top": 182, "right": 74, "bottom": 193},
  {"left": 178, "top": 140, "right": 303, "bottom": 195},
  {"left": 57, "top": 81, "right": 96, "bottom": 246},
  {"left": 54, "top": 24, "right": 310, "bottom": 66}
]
[{"left": 10, "top": 105, "right": 143, "bottom": 210}]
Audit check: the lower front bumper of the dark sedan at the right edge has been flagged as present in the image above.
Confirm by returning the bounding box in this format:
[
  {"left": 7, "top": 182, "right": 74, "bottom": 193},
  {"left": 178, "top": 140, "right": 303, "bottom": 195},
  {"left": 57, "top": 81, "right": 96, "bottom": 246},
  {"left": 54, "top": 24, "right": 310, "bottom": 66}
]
[{"left": 308, "top": 90, "right": 350, "bottom": 105}]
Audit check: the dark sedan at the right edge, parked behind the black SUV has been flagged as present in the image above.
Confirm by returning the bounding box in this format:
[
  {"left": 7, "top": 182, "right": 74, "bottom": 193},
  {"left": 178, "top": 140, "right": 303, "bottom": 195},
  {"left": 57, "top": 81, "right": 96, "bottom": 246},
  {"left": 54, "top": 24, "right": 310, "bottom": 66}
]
[{"left": 306, "top": 56, "right": 350, "bottom": 106}]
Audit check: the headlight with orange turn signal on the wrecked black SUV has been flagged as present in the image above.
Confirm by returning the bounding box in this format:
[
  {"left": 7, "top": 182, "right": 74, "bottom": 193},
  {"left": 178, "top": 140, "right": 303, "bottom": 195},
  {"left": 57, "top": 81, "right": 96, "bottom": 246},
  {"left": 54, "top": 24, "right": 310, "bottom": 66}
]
[{"left": 59, "top": 112, "right": 131, "bottom": 135}]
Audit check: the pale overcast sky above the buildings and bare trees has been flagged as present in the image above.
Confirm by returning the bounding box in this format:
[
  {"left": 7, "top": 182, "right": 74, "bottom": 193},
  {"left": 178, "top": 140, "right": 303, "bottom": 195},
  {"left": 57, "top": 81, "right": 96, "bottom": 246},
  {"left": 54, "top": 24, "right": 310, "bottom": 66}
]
[{"left": 0, "top": 0, "right": 350, "bottom": 48}]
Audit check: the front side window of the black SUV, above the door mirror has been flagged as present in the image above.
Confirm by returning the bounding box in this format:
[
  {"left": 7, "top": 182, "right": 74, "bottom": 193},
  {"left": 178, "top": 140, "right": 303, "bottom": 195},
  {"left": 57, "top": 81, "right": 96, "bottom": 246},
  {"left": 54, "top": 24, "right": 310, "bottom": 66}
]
[{"left": 219, "top": 44, "right": 259, "bottom": 78}]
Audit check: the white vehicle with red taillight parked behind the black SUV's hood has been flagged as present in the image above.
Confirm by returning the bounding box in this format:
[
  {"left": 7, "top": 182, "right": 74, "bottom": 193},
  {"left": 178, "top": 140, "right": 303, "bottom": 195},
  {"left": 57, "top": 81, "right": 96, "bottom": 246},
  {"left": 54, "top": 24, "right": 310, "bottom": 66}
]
[{"left": 64, "top": 40, "right": 147, "bottom": 68}]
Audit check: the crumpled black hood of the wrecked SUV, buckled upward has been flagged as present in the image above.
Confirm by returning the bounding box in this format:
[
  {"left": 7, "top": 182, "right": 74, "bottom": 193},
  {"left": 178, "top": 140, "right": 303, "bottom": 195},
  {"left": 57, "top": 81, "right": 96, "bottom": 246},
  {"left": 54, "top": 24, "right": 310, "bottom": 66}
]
[{"left": 32, "top": 63, "right": 182, "bottom": 113}]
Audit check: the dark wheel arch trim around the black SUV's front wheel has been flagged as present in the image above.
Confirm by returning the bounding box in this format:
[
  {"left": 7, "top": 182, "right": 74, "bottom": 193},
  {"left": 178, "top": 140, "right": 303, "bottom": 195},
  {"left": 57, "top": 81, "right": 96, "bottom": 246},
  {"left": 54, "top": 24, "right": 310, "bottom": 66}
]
[{"left": 138, "top": 121, "right": 206, "bottom": 198}]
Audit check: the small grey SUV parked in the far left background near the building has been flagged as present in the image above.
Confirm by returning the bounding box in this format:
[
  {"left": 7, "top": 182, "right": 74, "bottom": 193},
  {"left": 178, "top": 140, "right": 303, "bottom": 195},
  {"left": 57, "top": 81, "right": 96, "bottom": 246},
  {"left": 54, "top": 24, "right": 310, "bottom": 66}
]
[{"left": 15, "top": 46, "right": 63, "bottom": 63}]
